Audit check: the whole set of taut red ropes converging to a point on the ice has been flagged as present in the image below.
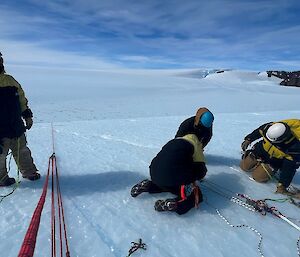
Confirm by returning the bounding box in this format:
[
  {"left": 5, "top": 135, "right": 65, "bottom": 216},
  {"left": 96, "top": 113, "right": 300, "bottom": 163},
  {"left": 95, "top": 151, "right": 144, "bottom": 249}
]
[{"left": 18, "top": 124, "right": 70, "bottom": 257}]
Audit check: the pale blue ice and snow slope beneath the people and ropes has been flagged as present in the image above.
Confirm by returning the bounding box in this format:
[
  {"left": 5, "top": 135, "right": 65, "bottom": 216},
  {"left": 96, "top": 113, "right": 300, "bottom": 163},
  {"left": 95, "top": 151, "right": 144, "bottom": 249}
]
[{"left": 0, "top": 69, "right": 300, "bottom": 257}]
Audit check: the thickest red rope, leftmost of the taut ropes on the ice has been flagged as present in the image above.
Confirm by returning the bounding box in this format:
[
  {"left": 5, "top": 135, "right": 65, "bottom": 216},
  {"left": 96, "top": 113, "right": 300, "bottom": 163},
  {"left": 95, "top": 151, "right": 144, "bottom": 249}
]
[{"left": 18, "top": 159, "right": 50, "bottom": 257}]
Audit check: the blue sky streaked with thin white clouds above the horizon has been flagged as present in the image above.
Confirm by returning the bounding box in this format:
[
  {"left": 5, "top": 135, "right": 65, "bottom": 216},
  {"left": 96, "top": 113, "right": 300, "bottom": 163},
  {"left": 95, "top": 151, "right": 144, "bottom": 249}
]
[{"left": 0, "top": 0, "right": 300, "bottom": 70}]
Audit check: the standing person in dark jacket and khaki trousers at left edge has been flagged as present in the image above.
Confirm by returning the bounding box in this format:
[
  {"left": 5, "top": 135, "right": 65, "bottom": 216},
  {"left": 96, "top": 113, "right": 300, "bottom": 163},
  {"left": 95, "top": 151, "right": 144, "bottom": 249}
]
[{"left": 0, "top": 52, "right": 40, "bottom": 186}]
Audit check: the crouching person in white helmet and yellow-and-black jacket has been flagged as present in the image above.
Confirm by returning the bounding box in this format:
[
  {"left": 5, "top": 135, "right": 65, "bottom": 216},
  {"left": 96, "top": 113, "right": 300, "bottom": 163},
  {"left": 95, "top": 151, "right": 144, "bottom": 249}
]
[{"left": 240, "top": 119, "right": 300, "bottom": 195}]
